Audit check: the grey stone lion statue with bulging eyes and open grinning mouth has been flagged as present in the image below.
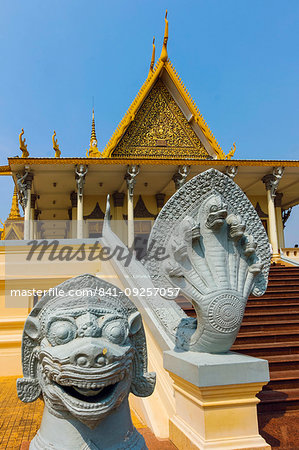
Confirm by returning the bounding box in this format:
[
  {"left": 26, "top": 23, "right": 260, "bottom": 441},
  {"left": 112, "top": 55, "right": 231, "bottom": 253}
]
[{"left": 17, "top": 274, "right": 155, "bottom": 450}]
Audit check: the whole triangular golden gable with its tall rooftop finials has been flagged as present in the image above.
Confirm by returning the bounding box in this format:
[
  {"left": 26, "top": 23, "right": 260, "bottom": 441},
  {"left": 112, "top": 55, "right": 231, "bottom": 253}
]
[{"left": 103, "top": 11, "right": 235, "bottom": 159}]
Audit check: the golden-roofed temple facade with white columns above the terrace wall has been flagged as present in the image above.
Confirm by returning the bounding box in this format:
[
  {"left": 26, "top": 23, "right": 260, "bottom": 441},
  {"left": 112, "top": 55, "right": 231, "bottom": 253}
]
[{"left": 0, "top": 14, "right": 299, "bottom": 260}]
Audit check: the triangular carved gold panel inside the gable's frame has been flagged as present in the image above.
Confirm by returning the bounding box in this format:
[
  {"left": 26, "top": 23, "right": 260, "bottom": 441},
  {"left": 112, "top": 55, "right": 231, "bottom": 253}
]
[{"left": 111, "top": 79, "right": 210, "bottom": 159}]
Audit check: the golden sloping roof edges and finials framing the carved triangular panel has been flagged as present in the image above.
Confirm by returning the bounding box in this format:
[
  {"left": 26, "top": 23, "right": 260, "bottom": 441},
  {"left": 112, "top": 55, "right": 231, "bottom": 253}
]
[{"left": 103, "top": 12, "right": 235, "bottom": 159}]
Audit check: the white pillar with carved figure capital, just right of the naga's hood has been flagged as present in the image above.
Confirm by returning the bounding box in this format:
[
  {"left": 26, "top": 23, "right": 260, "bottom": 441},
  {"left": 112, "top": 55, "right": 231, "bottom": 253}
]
[{"left": 262, "top": 167, "right": 283, "bottom": 261}]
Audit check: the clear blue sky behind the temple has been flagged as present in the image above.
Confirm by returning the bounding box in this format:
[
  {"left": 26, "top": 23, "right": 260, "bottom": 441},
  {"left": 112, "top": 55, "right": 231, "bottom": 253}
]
[{"left": 0, "top": 0, "right": 299, "bottom": 245}]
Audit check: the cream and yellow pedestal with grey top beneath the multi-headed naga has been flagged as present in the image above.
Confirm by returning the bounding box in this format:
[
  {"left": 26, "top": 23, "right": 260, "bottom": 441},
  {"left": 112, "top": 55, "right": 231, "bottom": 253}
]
[{"left": 164, "top": 351, "right": 271, "bottom": 450}]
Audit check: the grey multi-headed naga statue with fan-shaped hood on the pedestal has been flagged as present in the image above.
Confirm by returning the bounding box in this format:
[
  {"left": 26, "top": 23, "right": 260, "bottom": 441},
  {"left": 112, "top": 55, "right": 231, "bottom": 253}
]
[{"left": 145, "top": 169, "right": 270, "bottom": 353}]
